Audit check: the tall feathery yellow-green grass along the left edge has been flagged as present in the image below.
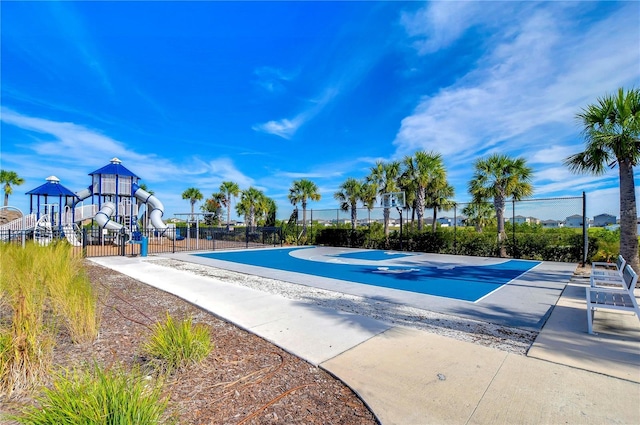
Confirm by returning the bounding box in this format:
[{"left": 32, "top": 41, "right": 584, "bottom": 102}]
[{"left": 0, "top": 241, "right": 99, "bottom": 395}]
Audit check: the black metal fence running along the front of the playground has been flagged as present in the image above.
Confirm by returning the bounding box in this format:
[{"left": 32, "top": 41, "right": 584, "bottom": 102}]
[{"left": 0, "top": 226, "right": 282, "bottom": 257}]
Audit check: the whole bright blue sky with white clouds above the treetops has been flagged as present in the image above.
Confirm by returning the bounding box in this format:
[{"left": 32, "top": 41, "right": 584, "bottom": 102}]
[{"left": 0, "top": 1, "right": 640, "bottom": 222}]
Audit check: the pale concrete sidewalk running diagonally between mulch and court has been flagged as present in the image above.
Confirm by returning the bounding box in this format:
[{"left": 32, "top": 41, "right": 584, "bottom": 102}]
[{"left": 91, "top": 257, "right": 640, "bottom": 425}]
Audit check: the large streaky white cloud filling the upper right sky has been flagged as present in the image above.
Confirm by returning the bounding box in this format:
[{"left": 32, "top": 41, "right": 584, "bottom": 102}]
[{"left": 394, "top": 2, "right": 640, "bottom": 199}]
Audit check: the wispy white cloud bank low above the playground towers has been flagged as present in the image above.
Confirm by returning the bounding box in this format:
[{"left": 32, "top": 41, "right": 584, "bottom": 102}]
[{"left": 1, "top": 107, "right": 254, "bottom": 216}]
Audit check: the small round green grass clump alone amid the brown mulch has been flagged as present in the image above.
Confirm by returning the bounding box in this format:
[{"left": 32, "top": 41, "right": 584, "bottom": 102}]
[{"left": 143, "top": 314, "right": 213, "bottom": 373}]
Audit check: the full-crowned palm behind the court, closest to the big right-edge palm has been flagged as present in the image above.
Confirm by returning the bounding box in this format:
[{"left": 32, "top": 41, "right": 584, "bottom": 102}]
[{"left": 469, "top": 154, "right": 533, "bottom": 257}]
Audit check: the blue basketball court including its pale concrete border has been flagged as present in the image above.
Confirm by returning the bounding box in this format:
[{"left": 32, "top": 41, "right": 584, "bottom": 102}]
[{"left": 167, "top": 246, "right": 576, "bottom": 331}]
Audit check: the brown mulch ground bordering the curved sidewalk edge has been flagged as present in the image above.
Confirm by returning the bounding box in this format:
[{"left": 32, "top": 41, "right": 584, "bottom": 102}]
[{"left": 0, "top": 261, "right": 377, "bottom": 425}]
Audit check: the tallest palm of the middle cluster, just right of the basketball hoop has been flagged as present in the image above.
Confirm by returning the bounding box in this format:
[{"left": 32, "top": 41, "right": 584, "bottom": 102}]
[{"left": 402, "top": 151, "right": 446, "bottom": 230}]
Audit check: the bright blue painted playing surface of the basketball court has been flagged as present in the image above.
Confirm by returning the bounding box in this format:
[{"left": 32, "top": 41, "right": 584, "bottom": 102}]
[{"left": 193, "top": 247, "right": 540, "bottom": 301}]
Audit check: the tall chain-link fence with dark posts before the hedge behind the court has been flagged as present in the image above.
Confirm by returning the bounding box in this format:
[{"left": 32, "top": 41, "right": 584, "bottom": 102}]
[{"left": 284, "top": 194, "right": 593, "bottom": 263}]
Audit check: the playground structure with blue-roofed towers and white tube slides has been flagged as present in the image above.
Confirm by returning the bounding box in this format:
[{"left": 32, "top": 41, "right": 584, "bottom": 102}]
[{"left": 0, "top": 158, "right": 175, "bottom": 246}]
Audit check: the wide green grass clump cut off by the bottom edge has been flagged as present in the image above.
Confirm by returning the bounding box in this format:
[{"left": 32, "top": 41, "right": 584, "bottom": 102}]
[{"left": 10, "top": 365, "right": 168, "bottom": 425}]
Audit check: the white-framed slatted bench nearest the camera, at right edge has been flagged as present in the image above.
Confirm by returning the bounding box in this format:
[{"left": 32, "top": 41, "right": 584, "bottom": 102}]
[{"left": 586, "top": 264, "right": 640, "bottom": 334}]
